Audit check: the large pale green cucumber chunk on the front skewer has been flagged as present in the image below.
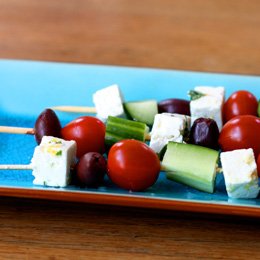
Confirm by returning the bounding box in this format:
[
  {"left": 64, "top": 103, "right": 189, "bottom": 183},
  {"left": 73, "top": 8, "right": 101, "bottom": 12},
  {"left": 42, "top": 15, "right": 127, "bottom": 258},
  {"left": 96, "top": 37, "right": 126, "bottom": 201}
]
[{"left": 162, "top": 142, "right": 219, "bottom": 193}]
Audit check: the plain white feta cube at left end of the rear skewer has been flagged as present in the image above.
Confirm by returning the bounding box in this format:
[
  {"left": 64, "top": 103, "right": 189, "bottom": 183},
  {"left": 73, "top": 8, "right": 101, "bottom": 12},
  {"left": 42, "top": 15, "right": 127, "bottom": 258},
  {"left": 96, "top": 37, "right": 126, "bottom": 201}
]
[{"left": 93, "top": 85, "right": 124, "bottom": 121}]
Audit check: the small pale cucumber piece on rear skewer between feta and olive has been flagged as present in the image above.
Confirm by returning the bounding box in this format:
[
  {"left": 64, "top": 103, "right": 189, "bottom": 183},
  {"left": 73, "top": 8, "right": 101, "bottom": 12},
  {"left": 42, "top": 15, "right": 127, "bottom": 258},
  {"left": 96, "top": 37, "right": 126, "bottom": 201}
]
[{"left": 124, "top": 99, "right": 158, "bottom": 125}]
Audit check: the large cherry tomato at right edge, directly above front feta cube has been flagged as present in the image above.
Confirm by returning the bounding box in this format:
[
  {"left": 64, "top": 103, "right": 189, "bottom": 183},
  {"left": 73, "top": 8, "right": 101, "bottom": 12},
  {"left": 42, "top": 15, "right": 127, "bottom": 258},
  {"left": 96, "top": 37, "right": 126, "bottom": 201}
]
[{"left": 218, "top": 115, "right": 260, "bottom": 158}]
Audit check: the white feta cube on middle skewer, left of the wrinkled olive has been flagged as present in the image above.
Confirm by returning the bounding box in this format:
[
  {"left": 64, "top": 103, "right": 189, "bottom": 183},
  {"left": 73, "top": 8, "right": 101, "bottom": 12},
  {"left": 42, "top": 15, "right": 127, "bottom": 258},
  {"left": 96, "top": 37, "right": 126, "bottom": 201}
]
[{"left": 150, "top": 113, "right": 190, "bottom": 153}]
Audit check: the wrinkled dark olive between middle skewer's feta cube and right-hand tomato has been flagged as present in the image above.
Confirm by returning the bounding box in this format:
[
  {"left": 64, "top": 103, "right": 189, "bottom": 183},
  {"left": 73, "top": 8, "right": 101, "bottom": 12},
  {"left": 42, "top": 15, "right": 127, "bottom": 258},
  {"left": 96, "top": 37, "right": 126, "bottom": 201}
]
[{"left": 189, "top": 118, "right": 219, "bottom": 150}]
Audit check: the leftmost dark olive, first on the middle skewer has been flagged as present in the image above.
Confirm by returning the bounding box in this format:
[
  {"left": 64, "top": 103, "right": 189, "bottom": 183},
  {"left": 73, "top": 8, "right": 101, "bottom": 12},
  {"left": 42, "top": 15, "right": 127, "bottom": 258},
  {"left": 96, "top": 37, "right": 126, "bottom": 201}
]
[{"left": 34, "top": 108, "right": 61, "bottom": 144}]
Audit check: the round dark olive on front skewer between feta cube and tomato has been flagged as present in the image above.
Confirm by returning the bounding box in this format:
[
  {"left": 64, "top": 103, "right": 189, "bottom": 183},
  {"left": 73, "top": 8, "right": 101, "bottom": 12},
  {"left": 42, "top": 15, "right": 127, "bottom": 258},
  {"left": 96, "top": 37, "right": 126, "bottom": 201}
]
[{"left": 76, "top": 152, "right": 107, "bottom": 187}]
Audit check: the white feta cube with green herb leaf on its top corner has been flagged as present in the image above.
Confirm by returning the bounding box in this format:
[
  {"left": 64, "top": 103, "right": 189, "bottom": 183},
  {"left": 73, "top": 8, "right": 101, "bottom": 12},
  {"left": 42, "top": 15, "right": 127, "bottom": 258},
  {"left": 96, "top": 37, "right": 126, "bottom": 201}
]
[{"left": 190, "top": 86, "right": 225, "bottom": 131}]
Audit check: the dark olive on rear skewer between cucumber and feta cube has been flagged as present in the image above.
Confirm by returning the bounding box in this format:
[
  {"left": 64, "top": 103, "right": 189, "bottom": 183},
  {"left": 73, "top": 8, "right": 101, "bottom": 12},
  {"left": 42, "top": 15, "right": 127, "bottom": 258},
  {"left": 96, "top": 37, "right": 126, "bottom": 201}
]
[{"left": 158, "top": 98, "right": 190, "bottom": 116}]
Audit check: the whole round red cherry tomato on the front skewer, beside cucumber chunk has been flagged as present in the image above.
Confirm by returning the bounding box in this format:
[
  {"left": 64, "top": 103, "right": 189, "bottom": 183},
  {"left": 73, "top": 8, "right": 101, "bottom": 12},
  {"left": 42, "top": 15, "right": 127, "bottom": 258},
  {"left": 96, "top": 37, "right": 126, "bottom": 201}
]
[{"left": 108, "top": 139, "right": 160, "bottom": 191}]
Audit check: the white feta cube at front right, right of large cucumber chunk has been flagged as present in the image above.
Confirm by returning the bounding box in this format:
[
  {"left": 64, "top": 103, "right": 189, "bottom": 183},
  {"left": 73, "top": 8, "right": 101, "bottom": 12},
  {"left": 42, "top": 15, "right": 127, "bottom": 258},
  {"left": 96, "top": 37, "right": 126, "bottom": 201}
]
[{"left": 220, "top": 148, "right": 259, "bottom": 199}]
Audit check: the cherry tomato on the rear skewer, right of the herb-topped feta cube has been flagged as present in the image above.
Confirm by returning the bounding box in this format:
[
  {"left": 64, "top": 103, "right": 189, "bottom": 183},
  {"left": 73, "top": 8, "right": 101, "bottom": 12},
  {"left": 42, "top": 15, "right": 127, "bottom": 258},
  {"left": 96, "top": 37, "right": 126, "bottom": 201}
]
[{"left": 223, "top": 90, "right": 258, "bottom": 122}]
